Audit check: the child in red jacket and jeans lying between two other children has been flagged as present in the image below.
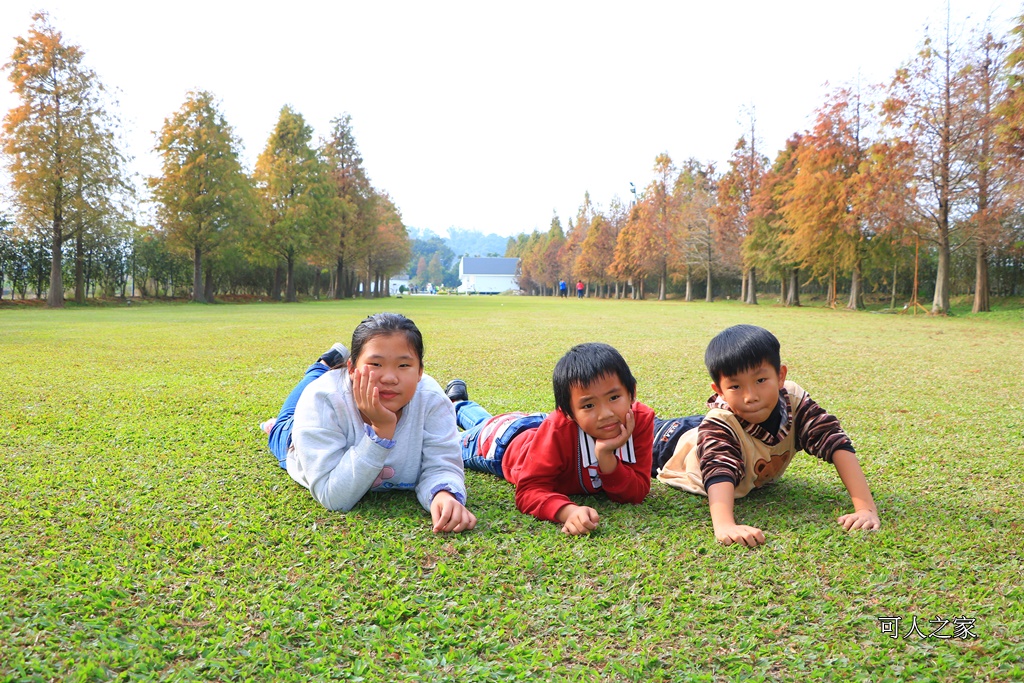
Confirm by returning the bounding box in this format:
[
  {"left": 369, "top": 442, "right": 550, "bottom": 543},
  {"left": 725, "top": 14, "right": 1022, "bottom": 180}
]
[{"left": 445, "top": 343, "right": 654, "bottom": 535}]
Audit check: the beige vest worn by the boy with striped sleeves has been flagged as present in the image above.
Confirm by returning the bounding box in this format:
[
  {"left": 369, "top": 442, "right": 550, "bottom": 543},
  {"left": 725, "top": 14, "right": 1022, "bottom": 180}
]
[{"left": 657, "top": 381, "right": 805, "bottom": 498}]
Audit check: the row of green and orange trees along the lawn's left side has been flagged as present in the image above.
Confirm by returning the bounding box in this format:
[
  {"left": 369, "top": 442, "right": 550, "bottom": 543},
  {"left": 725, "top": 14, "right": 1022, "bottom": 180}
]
[{"left": 0, "top": 12, "right": 412, "bottom": 307}]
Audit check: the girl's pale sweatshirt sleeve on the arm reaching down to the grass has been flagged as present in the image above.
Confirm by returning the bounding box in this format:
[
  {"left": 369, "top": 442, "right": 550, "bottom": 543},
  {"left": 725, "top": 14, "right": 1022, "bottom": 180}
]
[{"left": 416, "top": 395, "right": 466, "bottom": 511}]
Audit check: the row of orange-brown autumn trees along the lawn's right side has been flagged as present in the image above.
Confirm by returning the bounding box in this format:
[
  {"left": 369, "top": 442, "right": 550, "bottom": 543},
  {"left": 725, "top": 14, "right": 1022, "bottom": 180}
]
[{"left": 506, "top": 16, "right": 1024, "bottom": 313}]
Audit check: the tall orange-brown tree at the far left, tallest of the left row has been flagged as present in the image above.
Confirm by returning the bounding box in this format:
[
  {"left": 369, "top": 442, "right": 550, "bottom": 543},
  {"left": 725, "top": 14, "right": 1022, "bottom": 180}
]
[{"left": 0, "top": 12, "right": 128, "bottom": 308}]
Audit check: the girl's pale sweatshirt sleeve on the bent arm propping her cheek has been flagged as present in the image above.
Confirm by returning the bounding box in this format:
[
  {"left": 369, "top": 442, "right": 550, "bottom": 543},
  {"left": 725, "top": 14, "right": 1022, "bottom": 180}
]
[{"left": 292, "top": 385, "right": 390, "bottom": 512}]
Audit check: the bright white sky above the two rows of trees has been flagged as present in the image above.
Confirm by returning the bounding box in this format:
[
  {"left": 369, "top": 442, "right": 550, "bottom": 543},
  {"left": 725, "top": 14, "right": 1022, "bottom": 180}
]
[{"left": 0, "top": 0, "right": 1024, "bottom": 236}]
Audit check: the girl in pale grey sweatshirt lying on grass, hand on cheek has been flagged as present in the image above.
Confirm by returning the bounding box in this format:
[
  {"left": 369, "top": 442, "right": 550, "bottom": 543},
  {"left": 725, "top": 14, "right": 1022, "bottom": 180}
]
[{"left": 260, "top": 313, "right": 476, "bottom": 532}]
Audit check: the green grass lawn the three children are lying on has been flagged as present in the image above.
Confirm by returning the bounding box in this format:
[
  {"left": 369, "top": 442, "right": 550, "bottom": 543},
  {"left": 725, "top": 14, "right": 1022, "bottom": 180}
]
[{"left": 0, "top": 297, "right": 1024, "bottom": 683}]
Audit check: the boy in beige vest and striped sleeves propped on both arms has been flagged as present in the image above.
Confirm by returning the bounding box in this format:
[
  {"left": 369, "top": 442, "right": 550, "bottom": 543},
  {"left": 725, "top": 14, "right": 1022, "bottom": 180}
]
[{"left": 657, "top": 325, "right": 881, "bottom": 548}]
